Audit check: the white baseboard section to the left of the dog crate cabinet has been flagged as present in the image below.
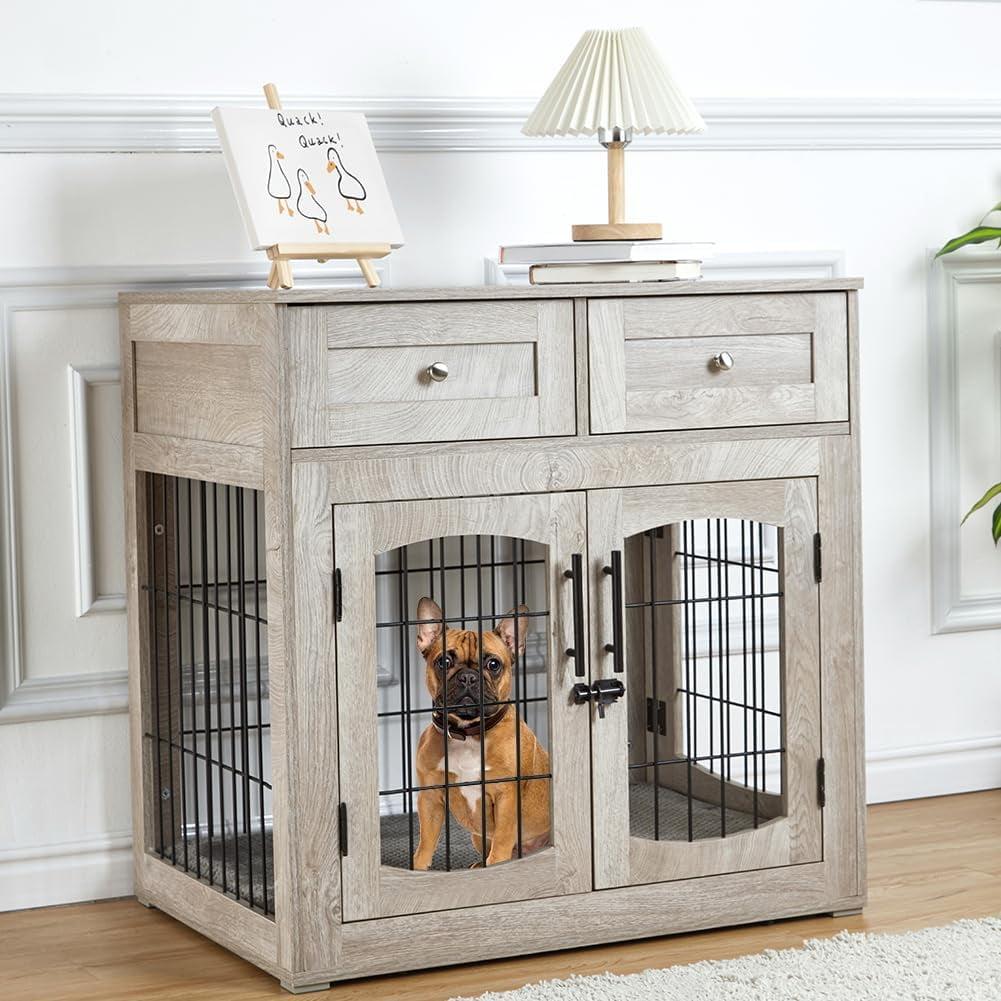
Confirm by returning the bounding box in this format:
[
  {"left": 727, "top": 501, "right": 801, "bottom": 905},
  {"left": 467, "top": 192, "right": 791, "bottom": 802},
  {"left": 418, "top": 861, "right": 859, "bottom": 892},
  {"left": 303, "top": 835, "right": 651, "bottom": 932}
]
[{"left": 0, "top": 832, "right": 132, "bottom": 911}]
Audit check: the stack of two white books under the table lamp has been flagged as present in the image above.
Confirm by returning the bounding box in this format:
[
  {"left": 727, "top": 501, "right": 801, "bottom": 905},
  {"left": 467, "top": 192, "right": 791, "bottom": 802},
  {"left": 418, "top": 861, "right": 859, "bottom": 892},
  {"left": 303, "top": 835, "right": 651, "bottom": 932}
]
[{"left": 501, "top": 240, "right": 713, "bottom": 285}]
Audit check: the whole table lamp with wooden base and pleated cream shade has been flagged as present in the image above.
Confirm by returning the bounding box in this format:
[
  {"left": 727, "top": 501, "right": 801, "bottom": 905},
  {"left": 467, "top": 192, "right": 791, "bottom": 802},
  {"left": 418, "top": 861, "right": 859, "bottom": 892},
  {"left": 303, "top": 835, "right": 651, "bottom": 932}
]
[{"left": 522, "top": 28, "right": 706, "bottom": 240}]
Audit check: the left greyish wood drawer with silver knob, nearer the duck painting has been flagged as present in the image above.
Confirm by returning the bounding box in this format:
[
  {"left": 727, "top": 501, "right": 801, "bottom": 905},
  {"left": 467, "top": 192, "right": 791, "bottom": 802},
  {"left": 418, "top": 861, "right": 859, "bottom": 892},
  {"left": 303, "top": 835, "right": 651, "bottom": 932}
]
[{"left": 288, "top": 300, "right": 577, "bottom": 447}]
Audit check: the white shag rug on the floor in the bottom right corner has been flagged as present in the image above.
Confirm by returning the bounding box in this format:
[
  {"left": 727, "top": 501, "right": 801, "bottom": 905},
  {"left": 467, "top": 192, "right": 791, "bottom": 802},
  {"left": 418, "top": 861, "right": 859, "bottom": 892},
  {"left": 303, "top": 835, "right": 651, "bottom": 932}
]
[{"left": 452, "top": 918, "right": 1001, "bottom": 1001}]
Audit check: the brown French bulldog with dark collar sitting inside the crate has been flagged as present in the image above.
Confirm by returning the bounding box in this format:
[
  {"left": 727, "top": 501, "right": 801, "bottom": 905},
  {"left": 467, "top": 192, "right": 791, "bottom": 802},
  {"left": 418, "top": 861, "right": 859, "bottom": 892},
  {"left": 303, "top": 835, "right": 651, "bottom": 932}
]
[{"left": 413, "top": 598, "right": 550, "bottom": 869}]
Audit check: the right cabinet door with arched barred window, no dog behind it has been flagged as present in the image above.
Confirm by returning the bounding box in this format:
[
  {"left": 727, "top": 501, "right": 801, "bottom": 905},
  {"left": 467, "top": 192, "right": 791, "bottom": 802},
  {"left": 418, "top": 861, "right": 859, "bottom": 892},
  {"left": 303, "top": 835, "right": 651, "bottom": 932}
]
[{"left": 588, "top": 479, "right": 822, "bottom": 888}]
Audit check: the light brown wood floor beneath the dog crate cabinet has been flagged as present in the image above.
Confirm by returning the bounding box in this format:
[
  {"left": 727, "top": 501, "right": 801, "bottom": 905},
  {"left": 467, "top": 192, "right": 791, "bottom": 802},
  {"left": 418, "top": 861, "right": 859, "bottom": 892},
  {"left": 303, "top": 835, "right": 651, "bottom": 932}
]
[{"left": 0, "top": 790, "right": 1001, "bottom": 1001}]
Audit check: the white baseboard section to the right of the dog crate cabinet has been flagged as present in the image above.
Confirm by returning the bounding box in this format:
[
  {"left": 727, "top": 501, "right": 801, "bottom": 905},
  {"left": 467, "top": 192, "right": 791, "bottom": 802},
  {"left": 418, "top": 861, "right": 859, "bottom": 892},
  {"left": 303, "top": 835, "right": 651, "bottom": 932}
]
[{"left": 866, "top": 734, "right": 1001, "bottom": 803}]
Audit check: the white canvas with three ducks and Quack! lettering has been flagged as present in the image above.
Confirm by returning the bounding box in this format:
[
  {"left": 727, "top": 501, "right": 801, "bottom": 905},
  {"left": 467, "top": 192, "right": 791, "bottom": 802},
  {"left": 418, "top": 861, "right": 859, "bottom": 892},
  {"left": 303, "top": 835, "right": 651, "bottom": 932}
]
[{"left": 212, "top": 108, "right": 403, "bottom": 250}]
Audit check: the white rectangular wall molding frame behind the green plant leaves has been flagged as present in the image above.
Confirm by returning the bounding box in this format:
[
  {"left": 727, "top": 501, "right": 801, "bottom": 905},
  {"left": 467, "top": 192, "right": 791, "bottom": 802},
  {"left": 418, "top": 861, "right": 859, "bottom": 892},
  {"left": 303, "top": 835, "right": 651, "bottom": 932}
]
[{"left": 928, "top": 251, "right": 1001, "bottom": 633}]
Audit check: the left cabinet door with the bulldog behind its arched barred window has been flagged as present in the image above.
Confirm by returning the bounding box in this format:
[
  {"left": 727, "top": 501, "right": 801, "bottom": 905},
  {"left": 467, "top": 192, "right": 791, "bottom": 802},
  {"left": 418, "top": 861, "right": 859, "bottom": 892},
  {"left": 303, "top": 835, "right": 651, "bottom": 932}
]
[{"left": 333, "top": 493, "right": 591, "bottom": 921}]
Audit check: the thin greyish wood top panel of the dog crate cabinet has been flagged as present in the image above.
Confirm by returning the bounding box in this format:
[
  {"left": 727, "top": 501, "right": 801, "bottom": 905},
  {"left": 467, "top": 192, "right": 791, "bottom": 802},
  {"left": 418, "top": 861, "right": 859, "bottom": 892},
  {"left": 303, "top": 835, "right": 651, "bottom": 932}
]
[{"left": 119, "top": 278, "right": 863, "bottom": 305}]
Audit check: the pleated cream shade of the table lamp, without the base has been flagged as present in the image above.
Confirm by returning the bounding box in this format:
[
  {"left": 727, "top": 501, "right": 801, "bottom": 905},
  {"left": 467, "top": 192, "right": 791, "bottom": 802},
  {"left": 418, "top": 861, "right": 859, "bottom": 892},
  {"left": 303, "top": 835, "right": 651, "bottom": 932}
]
[{"left": 522, "top": 28, "right": 706, "bottom": 136}]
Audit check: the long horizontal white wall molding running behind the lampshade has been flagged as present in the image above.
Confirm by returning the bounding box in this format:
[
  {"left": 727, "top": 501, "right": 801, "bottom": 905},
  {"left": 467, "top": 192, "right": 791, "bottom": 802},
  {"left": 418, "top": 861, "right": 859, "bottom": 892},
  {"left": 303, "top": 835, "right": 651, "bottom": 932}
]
[{"left": 0, "top": 94, "right": 1001, "bottom": 153}]
